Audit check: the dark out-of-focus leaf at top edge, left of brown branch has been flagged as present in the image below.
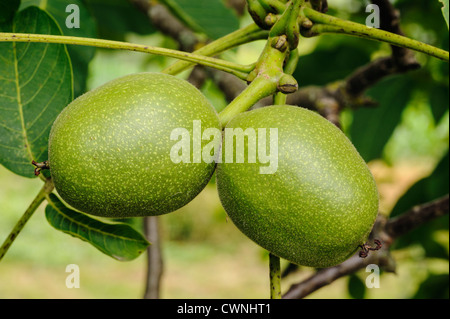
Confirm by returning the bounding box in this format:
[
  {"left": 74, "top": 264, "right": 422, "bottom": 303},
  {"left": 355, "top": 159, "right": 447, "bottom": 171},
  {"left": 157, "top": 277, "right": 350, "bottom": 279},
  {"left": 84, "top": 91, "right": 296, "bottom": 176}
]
[{"left": 84, "top": 0, "right": 155, "bottom": 41}]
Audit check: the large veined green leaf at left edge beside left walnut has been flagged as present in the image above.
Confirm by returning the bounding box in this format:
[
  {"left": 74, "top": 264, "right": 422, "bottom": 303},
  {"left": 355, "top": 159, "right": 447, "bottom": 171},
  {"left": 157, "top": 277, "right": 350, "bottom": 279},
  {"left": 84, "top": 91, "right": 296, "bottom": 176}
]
[{"left": 0, "top": 7, "right": 73, "bottom": 177}]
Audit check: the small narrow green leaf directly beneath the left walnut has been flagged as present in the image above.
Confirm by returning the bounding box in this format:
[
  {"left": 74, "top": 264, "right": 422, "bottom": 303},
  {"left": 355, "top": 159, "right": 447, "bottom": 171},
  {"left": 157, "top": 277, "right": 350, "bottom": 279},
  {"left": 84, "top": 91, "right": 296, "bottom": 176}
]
[{"left": 45, "top": 194, "right": 150, "bottom": 261}]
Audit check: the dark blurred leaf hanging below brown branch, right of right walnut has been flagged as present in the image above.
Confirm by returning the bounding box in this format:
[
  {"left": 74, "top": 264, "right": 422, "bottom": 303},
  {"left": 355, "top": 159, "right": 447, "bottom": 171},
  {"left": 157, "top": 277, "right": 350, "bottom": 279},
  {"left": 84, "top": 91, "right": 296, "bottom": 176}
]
[{"left": 350, "top": 76, "right": 412, "bottom": 162}]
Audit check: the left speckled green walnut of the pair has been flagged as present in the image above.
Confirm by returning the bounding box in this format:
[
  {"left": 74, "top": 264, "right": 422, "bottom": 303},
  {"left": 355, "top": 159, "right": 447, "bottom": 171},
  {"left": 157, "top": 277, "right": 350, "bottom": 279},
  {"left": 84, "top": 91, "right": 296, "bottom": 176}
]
[{"left": 49, "top": 73, "right": 220, "bottom": 217}]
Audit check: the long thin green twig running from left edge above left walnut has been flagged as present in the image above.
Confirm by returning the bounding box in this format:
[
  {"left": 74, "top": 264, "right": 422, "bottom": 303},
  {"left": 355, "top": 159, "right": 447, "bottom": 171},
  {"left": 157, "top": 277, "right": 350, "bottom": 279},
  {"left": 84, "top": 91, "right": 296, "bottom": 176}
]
[{"left": 0, "top": 32, "right": 253, "bottom": 80}]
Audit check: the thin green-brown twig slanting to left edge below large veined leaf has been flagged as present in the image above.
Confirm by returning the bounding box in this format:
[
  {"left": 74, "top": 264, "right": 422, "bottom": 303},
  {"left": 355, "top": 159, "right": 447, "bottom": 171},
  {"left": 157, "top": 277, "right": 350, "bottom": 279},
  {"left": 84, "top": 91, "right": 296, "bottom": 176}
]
[{"left": 0, "top": 179, "right": 54, "bottom": 261}]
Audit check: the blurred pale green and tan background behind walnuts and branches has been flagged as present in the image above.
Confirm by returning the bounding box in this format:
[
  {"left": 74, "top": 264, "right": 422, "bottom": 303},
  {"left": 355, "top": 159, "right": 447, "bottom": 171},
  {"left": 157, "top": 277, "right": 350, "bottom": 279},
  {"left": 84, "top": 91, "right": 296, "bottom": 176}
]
[{"left": 0, "top": 0, "right": 449, "bottom": 298}]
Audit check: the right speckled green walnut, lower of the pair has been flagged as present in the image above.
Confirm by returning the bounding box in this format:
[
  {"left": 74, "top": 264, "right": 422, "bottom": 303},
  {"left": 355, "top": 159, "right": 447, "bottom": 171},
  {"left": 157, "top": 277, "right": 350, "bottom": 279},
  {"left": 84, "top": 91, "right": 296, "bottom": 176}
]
[{"left": 217, "top": 105, "right": 378, "bottom": 268}]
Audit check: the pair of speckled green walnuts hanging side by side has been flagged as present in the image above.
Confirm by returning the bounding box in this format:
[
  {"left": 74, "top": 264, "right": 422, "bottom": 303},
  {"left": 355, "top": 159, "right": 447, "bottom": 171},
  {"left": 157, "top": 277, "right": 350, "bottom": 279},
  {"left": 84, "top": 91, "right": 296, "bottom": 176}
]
[{"left": 49, "top": 73, "right": 378, "bottom": 268}]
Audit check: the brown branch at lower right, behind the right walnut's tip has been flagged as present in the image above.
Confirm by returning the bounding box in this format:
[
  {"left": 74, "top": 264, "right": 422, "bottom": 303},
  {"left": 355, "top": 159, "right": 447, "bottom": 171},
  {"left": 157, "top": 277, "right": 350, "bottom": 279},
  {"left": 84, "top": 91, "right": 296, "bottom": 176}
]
[{"left": 283, "top": 195, "right": 449, "bottom": 299}]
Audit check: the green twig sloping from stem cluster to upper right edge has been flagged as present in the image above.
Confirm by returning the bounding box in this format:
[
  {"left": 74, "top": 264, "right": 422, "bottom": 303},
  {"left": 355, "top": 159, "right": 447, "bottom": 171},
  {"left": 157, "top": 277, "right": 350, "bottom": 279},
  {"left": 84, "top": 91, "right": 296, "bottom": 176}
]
[{"left": 302, "top": 7, "right": 449, "bottom": 62}]
